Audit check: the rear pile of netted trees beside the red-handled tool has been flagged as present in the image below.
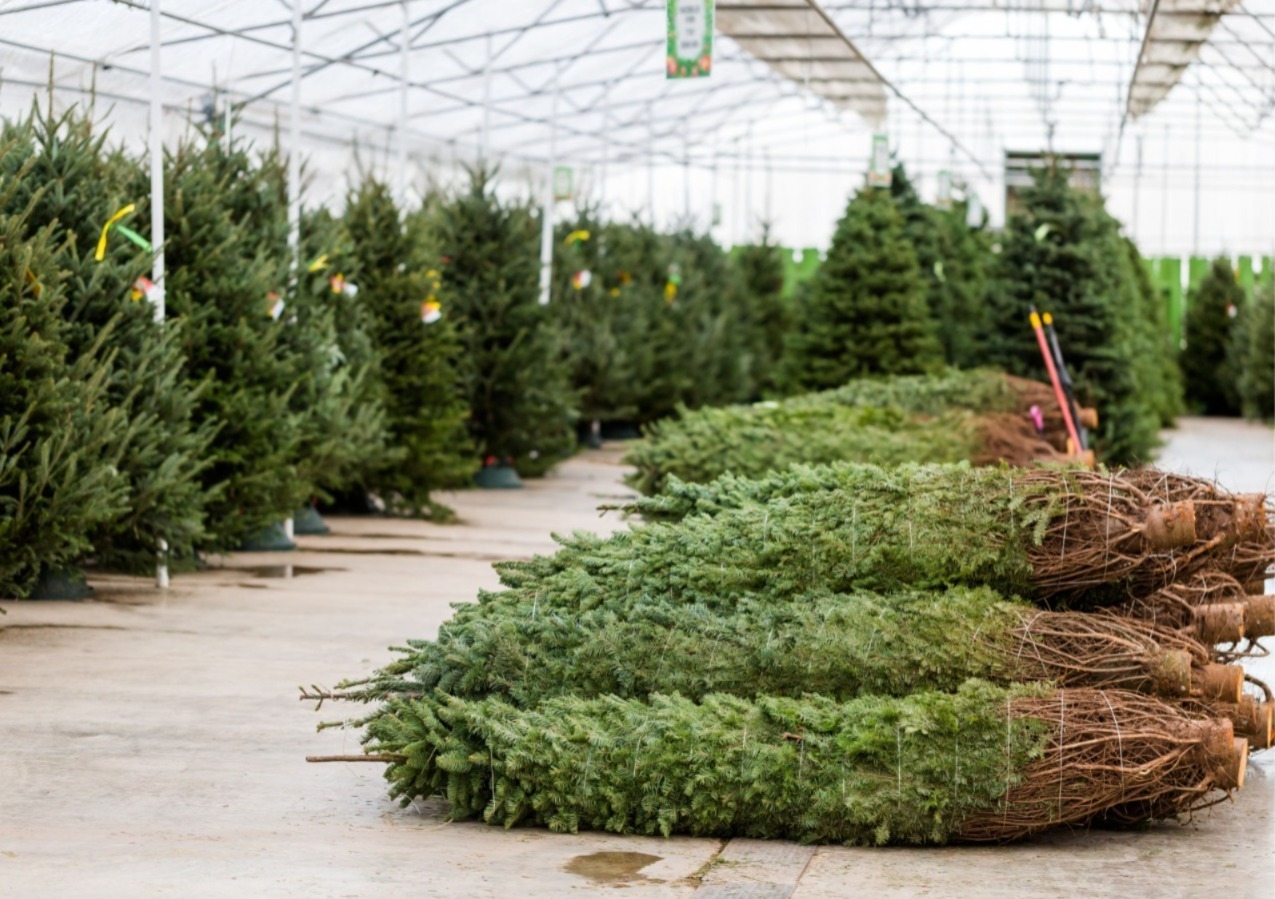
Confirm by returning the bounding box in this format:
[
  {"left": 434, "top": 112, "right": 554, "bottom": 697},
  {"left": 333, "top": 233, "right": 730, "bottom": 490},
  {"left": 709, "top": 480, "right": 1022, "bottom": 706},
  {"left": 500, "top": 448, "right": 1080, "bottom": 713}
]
[{"left": 625, "top": 369, "right": 1097, "bottom": 493}]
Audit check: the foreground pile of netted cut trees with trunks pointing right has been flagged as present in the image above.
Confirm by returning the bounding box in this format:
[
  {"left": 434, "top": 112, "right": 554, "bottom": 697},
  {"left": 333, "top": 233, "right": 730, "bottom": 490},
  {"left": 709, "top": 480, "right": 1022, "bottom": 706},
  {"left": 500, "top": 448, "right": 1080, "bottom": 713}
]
[{"left": 311, "top": 464, "right": 1275, "bottom": 844}]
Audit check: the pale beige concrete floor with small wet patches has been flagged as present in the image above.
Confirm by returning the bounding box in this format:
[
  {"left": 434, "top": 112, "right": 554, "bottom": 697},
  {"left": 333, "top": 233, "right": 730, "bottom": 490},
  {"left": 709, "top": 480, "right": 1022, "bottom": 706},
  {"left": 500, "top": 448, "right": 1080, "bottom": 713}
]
[{"left": 0, "top": 420, "right": 1275, "bottom": 899}]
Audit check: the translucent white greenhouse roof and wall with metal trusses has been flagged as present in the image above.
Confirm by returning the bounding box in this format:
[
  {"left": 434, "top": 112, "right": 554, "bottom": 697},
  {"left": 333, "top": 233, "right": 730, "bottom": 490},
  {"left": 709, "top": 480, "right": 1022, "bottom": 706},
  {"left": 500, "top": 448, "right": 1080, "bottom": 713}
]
[{"left": 0, "top": 0, "right": 1275, "bottom": 254}]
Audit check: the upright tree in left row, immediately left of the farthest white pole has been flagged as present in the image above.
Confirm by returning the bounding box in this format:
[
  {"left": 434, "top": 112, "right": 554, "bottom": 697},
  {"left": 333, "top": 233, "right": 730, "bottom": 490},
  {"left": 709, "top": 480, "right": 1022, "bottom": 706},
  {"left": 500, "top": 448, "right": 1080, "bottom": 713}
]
[{"left": 430, "top": 170, "right": 575, "bottom": 476}]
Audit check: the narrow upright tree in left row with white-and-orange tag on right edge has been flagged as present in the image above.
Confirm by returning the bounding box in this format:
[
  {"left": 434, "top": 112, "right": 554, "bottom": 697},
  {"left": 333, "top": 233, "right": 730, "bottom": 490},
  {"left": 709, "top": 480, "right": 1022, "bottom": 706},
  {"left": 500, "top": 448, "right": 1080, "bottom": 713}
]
[{"left": 342, "top": 179, "right": 478, "bottom": 507}]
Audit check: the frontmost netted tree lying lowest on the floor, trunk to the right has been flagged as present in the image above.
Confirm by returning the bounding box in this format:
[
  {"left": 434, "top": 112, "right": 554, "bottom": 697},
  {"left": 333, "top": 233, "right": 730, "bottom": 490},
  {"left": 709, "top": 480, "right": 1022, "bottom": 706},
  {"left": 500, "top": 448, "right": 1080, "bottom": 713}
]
[{"left": 354, "top": 681, "right": 1248, "bottom": 845}]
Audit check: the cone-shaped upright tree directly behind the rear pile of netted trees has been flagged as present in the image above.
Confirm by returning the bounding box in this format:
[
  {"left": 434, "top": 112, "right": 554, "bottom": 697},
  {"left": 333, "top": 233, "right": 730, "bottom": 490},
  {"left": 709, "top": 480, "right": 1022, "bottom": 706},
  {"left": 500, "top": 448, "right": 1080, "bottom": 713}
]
[{"left": 788, "top": 187, "right": 942, "bottom": 390}]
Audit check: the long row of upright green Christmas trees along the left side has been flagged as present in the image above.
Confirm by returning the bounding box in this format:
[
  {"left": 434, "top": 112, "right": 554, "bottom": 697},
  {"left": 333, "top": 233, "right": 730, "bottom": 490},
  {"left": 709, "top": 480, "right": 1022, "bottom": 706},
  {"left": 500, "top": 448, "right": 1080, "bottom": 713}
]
[{"left": 0, "top": 106, "right": 795, "bottom": 597}]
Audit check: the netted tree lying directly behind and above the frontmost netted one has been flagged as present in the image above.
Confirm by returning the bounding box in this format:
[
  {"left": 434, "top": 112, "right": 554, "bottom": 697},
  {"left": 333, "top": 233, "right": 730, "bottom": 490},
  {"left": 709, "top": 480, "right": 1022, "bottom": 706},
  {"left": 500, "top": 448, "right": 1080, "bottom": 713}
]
[{"left": 329, "top": 578, "right": 1243, "bottom": 717}]
